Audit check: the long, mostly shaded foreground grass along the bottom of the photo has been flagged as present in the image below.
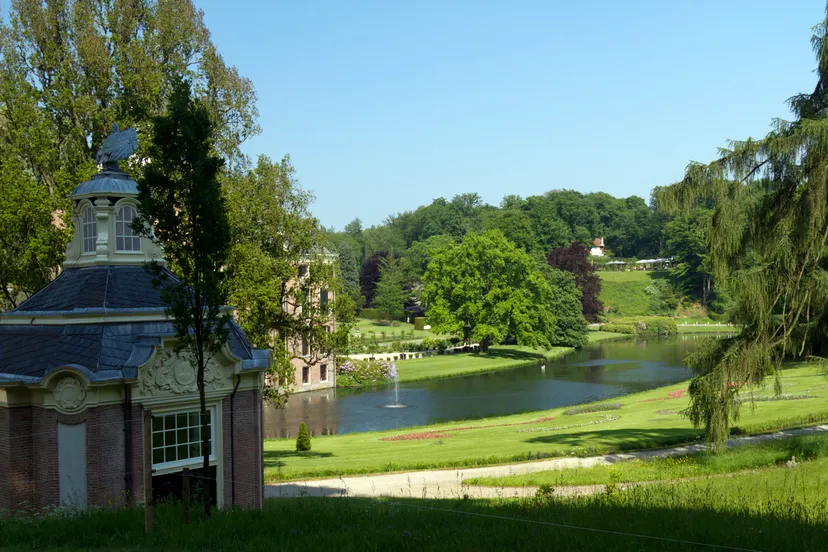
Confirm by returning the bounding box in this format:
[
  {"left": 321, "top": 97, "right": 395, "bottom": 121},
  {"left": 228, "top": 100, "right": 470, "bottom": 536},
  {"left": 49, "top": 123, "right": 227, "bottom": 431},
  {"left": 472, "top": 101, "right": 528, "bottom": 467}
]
[{"left": 0, "top": 460, "right": 828, "bottom": 552}]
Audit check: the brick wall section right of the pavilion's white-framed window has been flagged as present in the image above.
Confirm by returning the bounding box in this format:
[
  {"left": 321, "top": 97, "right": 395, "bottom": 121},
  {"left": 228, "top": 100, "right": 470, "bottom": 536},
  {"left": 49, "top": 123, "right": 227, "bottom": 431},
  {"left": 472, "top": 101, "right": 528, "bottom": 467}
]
[{"left": 222, "top": 390, "right": 264, "bottom": 509}]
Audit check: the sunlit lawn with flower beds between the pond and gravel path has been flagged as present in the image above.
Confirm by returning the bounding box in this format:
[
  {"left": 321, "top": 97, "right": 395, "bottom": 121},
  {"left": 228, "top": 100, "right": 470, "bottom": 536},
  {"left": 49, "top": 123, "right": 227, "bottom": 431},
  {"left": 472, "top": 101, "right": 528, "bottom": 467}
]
[{"left": 264, "top": 361, "right": 828, "bottom": 481}]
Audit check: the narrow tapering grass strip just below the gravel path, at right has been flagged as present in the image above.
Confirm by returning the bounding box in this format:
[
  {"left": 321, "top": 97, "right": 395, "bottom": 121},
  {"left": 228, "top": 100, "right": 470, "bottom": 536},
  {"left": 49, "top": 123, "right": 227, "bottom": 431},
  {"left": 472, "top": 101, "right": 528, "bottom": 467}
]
[{"left": 464, "top": 435, "right": 828, "bottom": 486}]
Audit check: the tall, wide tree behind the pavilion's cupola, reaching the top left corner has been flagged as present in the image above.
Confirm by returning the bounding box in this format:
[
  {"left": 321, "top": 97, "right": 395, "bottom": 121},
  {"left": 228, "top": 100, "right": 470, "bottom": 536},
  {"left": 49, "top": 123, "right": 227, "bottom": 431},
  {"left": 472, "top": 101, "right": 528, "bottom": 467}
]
[{"left": 0, "top": 0, "right": 258, "bottom": 306}]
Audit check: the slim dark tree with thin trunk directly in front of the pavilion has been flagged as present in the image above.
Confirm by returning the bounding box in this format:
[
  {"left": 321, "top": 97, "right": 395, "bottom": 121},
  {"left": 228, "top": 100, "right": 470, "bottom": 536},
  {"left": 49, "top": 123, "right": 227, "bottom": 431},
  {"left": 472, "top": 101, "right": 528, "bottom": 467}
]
[{"left": 134, "top": 81, "right": 230, "bottom": 516}]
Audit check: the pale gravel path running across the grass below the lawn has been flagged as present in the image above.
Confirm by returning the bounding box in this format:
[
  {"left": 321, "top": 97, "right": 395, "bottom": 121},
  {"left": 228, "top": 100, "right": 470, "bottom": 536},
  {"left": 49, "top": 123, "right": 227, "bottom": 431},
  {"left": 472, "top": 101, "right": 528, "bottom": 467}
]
[{"left": 265, "top": 424, "right": 828, "bottom": 498}]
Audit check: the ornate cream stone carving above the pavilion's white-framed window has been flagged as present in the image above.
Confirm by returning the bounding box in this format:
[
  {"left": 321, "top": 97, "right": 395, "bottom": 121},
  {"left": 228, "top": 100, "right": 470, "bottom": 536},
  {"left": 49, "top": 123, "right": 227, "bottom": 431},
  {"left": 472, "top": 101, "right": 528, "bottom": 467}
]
[{"left": 139, "top": 350, "right": 226, "bottom": 397}]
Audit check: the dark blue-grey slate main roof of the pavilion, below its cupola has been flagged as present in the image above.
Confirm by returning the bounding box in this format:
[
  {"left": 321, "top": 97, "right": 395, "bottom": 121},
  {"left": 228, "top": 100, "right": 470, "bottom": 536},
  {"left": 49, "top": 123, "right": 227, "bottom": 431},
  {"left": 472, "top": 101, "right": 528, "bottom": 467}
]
[{"left": 0, "top": 266, "right": 269, "bottom": 385}]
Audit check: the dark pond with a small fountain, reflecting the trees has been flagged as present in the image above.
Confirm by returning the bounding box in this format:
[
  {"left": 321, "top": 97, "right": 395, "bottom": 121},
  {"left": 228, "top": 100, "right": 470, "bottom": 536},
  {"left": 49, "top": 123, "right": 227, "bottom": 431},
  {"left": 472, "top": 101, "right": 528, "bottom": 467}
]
[{"left": 264, "top": 334, "right": 720, "bottom": 438}]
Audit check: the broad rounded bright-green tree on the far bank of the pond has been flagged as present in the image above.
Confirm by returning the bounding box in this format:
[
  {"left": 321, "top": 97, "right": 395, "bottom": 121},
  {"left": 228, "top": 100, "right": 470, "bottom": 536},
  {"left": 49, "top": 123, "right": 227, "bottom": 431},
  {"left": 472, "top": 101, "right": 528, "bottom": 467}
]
[{"left": 423, "top": 230, "right": 585, "bottom": 352}]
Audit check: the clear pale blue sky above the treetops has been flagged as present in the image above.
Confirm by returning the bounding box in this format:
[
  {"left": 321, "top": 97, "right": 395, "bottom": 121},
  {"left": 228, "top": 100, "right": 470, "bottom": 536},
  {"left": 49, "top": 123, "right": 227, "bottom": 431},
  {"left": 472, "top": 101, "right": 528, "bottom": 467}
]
[{"left": 196, "top": 0, "right": 825, "bottom": 229}]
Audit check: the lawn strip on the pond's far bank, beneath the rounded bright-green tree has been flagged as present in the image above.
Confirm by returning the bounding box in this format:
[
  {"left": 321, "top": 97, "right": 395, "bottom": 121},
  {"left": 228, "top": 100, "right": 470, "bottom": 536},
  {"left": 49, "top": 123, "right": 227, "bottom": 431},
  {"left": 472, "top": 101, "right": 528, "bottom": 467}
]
[{"left": 397, "top": 332, "right": 627, "bottom": 382}]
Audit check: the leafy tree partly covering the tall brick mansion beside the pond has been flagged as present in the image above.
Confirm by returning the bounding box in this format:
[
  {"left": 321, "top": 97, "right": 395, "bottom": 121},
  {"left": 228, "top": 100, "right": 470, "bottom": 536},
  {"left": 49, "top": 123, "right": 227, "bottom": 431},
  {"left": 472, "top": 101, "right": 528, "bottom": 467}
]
[{"left": 224, "top": 156, "right": 350, "bottom": 404}]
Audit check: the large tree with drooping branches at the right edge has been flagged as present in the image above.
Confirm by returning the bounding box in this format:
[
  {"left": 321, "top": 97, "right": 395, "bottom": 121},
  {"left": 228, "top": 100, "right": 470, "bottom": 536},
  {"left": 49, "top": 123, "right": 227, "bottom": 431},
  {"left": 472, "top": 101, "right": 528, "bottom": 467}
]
[{"left": 654, "top": 7, "right": 828, "bottom": 443}]
